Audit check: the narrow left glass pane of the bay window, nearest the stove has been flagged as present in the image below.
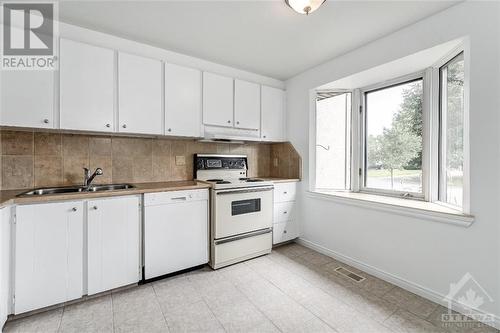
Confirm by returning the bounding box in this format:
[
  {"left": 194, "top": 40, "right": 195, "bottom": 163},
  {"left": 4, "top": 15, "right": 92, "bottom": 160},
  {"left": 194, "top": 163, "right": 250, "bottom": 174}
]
[{"left": 316, "top": 92, "right": 351, "bottom": 190}]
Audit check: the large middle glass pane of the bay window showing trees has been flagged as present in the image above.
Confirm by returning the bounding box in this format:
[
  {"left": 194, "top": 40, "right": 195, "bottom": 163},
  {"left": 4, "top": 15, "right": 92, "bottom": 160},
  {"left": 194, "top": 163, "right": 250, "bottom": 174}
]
[{"left": 364, "top": 78, "right": 423, "bottom": 196}]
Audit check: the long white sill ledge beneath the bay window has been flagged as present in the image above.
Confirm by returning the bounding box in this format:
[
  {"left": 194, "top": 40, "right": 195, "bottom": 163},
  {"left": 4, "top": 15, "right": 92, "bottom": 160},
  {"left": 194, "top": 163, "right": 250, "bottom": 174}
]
[{"left": 307, "top": 191, "right": 474, "bottom": 228}]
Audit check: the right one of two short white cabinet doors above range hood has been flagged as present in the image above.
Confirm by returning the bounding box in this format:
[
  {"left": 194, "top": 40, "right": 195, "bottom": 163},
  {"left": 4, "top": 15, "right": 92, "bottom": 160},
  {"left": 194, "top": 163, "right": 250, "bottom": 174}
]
[{"left": 234, "top": 80, "right": 260, "bottom": 130}]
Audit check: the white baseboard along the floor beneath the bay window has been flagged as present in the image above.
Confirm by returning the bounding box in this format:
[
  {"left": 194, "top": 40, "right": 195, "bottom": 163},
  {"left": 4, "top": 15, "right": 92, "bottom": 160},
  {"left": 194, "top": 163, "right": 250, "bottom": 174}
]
[{"left": 296, "top": 238, "right": 500, "bottom": 329}]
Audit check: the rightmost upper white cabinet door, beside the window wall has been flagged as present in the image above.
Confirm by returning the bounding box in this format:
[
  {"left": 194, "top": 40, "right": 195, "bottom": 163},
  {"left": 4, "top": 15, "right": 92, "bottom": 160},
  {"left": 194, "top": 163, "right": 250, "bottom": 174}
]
[{"left": 261, "top": 86, "right": 285, "bottom": 141}]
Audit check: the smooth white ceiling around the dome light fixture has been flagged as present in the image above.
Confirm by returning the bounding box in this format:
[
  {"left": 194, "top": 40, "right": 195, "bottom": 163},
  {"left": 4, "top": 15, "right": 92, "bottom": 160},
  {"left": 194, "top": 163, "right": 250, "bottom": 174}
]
[{"left": 59, "top": 0, "right": 456, "bottom": 80}]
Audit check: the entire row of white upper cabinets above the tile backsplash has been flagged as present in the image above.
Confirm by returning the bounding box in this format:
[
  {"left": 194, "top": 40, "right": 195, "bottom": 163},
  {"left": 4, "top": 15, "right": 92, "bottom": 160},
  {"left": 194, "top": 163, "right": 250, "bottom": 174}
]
[{"left": 0, "top": 39, "right": 284, "bottom": 140}]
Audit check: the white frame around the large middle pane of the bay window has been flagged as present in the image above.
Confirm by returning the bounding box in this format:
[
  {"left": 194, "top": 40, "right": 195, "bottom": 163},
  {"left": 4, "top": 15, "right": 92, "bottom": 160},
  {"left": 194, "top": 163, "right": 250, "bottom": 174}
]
[{"left": 358, "top": 71, "right": 429, "bottom": 200}]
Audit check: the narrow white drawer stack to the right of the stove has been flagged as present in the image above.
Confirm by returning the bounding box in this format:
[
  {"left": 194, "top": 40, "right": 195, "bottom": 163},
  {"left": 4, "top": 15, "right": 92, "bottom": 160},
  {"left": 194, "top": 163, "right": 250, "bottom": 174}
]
[{"left": 273, "top": 182, "right": 299, "bottom": 245}]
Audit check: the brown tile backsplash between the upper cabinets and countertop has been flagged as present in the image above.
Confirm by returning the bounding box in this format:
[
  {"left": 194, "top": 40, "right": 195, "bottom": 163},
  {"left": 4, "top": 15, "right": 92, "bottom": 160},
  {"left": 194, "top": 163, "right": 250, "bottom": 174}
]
[{"left": 0, "top": 129, "right": 301, "bottom": 190}]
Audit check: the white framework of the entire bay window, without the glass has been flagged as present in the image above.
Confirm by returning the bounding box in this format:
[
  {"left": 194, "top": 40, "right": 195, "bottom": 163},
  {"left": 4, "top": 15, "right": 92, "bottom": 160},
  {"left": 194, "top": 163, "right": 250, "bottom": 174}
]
[{"left": 308, "top": 41, "right": 470, "bottom": 216}]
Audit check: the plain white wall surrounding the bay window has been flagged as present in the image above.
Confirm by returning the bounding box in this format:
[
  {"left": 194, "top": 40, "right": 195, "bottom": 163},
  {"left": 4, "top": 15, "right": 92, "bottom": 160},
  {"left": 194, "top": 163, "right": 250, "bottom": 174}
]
[{"left": 287, "top": 2, "right": 500, "bottom": 316}]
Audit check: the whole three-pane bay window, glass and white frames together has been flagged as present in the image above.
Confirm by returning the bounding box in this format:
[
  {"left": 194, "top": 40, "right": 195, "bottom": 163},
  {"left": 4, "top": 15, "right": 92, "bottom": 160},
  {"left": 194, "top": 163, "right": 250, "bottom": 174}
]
[{"left": 311, "top": 50, "right": 468, "bottom": 213}]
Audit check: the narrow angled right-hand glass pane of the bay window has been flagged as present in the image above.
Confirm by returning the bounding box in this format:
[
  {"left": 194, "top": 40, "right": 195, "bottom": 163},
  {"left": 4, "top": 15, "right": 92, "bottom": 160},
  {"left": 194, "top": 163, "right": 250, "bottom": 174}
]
[{"left": 439, "top": 53, "right": 464, "bottom": 207}]
